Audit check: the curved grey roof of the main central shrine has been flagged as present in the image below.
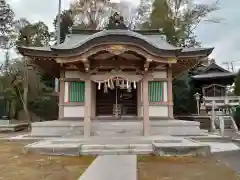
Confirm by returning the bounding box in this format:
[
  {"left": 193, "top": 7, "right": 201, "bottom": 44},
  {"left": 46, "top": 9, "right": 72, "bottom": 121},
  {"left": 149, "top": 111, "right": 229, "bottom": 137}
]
[{"left": 18, "top": 29, "right": 213, "bottom": 56}]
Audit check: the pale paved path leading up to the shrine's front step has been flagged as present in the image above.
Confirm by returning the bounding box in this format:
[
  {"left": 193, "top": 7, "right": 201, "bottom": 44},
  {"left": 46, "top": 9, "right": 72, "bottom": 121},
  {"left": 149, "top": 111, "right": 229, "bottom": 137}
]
[{"left": 78, "top": 155, "right": 137, "bottom": 180}]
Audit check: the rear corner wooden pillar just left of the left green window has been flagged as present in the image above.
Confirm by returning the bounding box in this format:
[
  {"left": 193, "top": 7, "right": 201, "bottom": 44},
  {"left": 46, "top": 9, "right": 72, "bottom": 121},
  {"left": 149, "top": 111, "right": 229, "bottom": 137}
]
[{"left": 58, "top": 70, "right": 65, "bottom": 119}]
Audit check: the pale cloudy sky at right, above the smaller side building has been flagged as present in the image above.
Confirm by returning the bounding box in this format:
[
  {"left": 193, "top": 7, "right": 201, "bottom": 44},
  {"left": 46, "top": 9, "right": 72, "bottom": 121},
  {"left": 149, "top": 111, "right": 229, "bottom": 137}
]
[{"left": 196, "top": 0, "right": 240, "bottom": 70}]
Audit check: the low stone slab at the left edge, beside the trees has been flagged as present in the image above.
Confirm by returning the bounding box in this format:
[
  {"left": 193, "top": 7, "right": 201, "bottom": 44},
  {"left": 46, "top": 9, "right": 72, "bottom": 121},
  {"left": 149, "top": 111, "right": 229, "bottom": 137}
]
[{"left": 0, "top": 120, "right": 29, "bottom": 132}]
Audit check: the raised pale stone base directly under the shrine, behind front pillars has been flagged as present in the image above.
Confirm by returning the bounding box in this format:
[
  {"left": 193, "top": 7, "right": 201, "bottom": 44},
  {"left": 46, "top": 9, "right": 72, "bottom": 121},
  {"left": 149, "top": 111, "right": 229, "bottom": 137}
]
[{"left": 31, "top": 120, "right": 205, "bottom": 137}]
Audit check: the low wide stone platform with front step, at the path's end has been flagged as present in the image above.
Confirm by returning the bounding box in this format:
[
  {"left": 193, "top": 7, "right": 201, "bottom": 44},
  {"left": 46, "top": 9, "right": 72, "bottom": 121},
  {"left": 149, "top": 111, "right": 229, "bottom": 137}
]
[{"left": 25, "top": 136, "right": 210, "bottom": 156}]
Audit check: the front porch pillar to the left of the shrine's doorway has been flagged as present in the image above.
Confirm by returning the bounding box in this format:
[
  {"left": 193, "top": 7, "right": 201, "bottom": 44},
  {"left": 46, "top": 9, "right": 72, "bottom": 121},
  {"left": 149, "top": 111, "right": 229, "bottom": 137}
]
[{"left": 84, "top": 79, "right": 92, "bottom": 137}]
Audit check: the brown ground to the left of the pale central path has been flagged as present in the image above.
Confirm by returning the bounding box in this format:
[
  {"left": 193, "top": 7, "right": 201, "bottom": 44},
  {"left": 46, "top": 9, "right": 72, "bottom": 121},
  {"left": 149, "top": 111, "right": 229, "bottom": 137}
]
[{"left": 0, "top": 141, "right": 95, "bottom": 180}]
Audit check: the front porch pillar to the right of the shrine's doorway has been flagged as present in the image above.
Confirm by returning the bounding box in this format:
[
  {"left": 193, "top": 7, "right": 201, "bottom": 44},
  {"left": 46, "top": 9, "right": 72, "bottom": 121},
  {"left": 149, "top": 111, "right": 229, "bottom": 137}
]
[{"left": 142, "top": 75, "right": 150, "bottom": 136}]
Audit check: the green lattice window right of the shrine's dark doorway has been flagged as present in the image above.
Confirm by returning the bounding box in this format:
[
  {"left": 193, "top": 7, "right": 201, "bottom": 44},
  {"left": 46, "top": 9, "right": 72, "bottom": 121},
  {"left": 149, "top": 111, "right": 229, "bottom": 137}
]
[{"left": 148, "top": 81, "right": 163, "bottom": 102}]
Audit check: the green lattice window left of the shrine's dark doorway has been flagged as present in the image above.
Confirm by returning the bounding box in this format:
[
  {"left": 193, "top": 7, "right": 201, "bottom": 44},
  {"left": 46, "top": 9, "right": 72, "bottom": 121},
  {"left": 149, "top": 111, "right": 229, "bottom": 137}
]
[{"left": 69, "top": 82, "right": 85, "bottom": 102}]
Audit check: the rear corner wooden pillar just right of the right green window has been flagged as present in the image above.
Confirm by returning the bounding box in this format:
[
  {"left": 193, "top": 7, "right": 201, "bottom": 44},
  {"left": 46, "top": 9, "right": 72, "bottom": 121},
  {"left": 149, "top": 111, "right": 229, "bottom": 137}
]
[{"left": 167, "top": 64, "right": 173, "bottom": 118}]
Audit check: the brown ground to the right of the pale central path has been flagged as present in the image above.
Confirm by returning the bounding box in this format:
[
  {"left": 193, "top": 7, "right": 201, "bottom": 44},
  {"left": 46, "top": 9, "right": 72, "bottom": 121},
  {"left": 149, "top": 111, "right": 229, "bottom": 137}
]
[{"left": 138, "top": 156, "right": 240, "bottom": 180}]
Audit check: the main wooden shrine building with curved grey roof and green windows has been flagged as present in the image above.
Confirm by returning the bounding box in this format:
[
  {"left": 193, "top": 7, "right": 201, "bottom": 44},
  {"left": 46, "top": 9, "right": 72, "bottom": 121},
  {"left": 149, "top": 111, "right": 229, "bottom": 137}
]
[{"left": 18, "top": 13, "right": 213, "bottom": 136}]
